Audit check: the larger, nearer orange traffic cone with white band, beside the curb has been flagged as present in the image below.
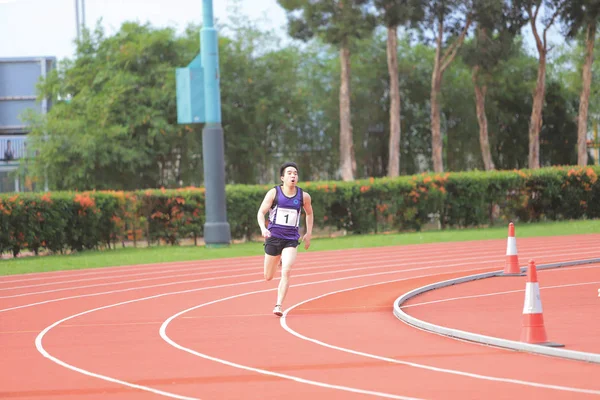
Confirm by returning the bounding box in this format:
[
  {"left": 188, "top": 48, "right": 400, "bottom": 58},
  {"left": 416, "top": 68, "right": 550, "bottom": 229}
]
[{"left": 521, "top": 260, "right": 564, "bottom": 347}]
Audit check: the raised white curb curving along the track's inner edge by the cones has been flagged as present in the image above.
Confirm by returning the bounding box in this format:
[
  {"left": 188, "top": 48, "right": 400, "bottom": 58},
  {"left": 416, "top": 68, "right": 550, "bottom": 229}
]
[{"left": 394, "top": 258, "right": 600, "bottom": 364}]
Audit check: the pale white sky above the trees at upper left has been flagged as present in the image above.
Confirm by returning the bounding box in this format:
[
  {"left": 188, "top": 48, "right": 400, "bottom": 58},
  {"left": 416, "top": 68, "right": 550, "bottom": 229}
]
[{"left": 0, "top": 0, "right": 286, "bottom": 59}]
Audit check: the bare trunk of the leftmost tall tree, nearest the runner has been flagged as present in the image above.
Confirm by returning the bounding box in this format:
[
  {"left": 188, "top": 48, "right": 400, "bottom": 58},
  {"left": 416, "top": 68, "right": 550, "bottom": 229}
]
[{"left": 340, "top": 44, "right": 356, "bottom": 181}]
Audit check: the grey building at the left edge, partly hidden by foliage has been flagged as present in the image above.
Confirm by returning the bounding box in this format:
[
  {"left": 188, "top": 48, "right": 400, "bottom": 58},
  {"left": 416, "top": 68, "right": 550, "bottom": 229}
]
[{"left": 0, "top": 57, "right": 56, "bottom": 193}]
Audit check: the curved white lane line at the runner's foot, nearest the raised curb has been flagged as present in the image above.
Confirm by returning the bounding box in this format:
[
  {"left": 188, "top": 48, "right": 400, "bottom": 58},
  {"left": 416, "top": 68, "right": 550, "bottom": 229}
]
[{"left": 280, "top": 281, "right": 600, "bottom": 394}]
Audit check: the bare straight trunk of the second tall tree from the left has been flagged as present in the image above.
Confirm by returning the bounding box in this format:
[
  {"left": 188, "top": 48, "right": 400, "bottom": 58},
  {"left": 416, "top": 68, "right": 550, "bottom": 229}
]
[{"left": 387, "top": 26, "right": 400, "bottom": 178}]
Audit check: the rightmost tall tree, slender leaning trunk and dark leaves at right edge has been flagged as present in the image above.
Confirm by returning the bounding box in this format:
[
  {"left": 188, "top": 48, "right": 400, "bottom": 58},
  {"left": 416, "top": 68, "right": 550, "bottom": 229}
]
[{"left": 560, "top": 0, "right": 600, "bottom": 166}]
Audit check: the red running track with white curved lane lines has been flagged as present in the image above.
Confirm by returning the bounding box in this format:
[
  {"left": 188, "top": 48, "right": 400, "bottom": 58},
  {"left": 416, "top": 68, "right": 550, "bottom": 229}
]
[{"left": 0, "top": 235, "right": 600, "bottom": 400}]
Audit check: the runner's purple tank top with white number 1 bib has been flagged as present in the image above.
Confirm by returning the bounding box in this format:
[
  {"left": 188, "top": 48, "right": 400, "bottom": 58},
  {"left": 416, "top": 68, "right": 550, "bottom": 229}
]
[{"left": 268, "top": 186, "right": 303, "bottom": 240}]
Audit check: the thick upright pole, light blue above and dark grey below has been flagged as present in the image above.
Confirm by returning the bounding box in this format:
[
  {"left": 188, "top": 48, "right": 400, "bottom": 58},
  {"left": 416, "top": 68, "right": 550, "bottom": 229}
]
[{"left": 200, "top": 0, "right": 231, "bottom": 247}]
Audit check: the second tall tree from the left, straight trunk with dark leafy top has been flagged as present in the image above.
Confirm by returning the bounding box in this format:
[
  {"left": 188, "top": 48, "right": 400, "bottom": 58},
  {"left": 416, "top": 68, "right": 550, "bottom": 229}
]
[{"left": 375, "top": 0, "right": 423, "bottom": 178}]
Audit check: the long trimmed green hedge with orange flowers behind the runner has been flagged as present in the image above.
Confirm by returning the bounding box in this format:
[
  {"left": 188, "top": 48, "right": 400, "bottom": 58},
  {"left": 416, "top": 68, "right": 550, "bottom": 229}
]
[{"left": 0, "top": 167, "right": 600, "bottom": 256}]
